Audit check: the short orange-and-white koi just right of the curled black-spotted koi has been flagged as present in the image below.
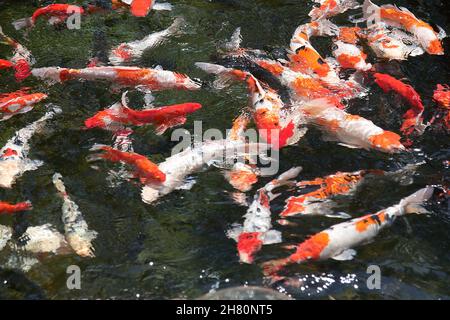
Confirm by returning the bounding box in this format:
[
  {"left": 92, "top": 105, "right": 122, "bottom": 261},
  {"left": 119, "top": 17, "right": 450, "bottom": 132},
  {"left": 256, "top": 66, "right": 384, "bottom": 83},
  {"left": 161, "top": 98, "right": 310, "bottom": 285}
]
[{"left": 332, "top": 27, "right": 372, "bottom": 71}]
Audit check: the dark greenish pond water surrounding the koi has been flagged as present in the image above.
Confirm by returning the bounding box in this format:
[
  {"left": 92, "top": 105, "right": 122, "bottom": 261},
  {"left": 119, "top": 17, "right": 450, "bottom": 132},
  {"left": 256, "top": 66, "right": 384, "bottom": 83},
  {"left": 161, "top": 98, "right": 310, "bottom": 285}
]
[{"left": 0, "top": 0, "right": 450, "bottom": 299}]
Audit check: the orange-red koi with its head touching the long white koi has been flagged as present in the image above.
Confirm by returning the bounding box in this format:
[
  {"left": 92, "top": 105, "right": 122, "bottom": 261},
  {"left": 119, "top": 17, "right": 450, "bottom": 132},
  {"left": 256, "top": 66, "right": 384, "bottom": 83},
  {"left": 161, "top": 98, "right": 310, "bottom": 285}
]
[{"left": 88, "top": 144, "right": 166, "bottom": 184}]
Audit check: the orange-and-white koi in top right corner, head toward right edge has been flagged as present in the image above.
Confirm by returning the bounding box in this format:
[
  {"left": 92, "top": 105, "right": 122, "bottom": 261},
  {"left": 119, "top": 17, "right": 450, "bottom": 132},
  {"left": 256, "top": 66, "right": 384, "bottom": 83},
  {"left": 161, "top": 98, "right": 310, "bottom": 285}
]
[{"left": 363, "top": 0, "right": 445, "bottom": 55}]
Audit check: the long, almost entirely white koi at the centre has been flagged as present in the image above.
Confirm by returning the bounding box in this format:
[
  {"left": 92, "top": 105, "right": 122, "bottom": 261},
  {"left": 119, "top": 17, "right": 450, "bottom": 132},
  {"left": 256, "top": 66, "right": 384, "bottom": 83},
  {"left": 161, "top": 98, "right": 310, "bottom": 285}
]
[{"left": 142, "top": 139, "right": 269, "bottom": 204}]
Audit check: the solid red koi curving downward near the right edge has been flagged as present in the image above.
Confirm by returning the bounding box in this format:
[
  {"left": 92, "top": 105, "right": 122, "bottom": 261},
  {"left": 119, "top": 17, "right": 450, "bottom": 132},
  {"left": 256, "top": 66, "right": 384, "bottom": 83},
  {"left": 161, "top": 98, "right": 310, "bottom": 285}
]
[{"left": 374, "top": 73, "right": 426, "bottom": 136}]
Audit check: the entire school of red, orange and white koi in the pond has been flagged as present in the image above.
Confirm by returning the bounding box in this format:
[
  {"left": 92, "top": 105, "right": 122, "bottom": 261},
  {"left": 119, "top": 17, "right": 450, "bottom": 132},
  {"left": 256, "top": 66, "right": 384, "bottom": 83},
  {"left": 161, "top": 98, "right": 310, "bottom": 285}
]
[{"left": 0, "top": 0, "right": 450, "bottom": 300}]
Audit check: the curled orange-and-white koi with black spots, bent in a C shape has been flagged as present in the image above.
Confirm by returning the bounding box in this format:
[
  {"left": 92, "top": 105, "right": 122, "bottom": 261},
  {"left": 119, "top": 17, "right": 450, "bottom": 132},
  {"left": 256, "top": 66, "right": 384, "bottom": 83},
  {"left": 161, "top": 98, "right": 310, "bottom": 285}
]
[{"left": 288, "top": 20, "right": 341, "bottom": 84}]
